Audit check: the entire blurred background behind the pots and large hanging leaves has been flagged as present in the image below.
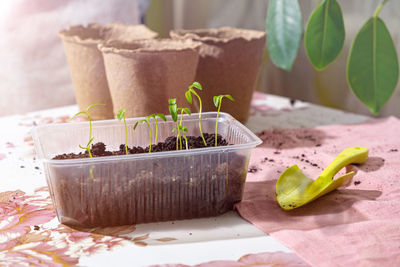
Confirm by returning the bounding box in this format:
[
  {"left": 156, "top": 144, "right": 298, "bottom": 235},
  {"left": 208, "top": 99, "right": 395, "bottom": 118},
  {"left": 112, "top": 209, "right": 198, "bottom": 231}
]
[{"left": 0, "top": 0, "right": 400, "bottom": 116}]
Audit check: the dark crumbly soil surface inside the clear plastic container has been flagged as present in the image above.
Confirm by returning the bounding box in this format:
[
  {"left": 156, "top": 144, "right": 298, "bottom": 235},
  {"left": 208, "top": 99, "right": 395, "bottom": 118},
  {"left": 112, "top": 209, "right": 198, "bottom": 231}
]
[{"left": 53, "top": 133, "right": 228, "bottom": 159}]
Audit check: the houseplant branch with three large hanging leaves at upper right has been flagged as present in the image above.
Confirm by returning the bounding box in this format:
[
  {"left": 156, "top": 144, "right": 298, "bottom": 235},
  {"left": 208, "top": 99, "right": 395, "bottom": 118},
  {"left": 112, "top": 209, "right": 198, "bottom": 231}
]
[{"left": 266, "top": 0, "right": 399, "bottom": 114}]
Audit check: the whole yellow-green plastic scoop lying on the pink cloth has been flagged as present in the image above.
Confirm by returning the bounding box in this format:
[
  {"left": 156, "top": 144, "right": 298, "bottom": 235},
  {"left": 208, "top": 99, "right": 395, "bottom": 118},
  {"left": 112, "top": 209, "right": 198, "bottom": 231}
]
[{"left": 275, "top": 147, "right": 368, "bottom": 210}]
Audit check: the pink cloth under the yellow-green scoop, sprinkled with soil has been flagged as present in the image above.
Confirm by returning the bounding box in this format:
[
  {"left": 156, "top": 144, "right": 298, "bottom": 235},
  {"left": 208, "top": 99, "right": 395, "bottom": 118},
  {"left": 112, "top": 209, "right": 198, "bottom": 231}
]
[{"left": 237, "top": 117, "right": 400, "bottom": 266}]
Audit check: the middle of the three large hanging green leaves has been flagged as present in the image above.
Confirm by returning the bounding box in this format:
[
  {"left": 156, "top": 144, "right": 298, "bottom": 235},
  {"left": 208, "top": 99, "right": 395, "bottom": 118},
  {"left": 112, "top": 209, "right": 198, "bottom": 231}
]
[{"left": 304, "top": 0, "right": 345, "bottom": 70}]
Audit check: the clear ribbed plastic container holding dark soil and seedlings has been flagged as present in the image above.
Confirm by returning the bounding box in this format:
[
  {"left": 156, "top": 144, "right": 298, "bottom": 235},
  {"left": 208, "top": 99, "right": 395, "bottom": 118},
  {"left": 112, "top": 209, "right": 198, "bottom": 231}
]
[{"left": 33, "top": 112, "right": 261, "bottom": 227}]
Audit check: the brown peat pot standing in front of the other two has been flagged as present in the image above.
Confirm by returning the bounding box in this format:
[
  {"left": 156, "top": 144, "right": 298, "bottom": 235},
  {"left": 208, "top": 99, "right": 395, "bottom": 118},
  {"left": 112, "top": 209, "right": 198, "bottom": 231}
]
[{"left": 99, "top": 39, "right": 200, "bottom": 117}]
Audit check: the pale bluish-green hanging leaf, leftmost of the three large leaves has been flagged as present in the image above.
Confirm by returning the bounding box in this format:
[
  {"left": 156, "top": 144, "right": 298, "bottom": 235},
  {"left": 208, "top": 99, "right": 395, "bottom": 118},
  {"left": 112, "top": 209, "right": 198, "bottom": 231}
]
[{"left": 266, "top": 0, "right": 302, "bottom": 71}]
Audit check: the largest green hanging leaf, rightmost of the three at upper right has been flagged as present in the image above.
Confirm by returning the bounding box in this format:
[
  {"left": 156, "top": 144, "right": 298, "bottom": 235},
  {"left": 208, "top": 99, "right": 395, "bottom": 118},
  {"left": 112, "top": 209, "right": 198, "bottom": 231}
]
[{"left": 346, "top": 17, "right": 399, "bottom": 114}]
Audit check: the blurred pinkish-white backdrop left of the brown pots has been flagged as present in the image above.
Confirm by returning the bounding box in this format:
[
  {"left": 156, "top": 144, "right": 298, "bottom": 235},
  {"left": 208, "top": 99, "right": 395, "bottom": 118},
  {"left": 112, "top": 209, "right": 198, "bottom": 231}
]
[{"left": 0, "top": 0, "right": 139, "bottom": 116}]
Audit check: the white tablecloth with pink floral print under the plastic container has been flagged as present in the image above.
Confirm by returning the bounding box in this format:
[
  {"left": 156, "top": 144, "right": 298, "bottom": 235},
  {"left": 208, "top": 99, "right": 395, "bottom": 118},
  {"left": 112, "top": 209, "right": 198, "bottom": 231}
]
[{"left": 0, "top": 93, "right": 366, "bottom": 266}]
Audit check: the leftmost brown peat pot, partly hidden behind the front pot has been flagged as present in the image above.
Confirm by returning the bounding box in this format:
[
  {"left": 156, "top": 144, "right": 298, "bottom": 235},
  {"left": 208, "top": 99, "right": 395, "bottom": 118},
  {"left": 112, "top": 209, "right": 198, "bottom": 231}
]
[{"left": 60, "top": 23, "right": 157, "bottom": 120}]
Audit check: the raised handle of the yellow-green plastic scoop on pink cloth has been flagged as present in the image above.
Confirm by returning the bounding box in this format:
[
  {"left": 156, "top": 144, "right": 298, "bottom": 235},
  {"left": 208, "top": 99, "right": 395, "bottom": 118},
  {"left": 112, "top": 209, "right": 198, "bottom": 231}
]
[{"left": 320, "top": 147, "right": 368, "bottom": 180}]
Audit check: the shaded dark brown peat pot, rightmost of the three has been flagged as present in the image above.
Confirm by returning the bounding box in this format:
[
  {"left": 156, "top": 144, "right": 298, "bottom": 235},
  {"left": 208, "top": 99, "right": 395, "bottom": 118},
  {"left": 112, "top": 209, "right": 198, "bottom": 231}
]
[{"left": 170, "top": 27, "right": 265, "bottom": 122}]
